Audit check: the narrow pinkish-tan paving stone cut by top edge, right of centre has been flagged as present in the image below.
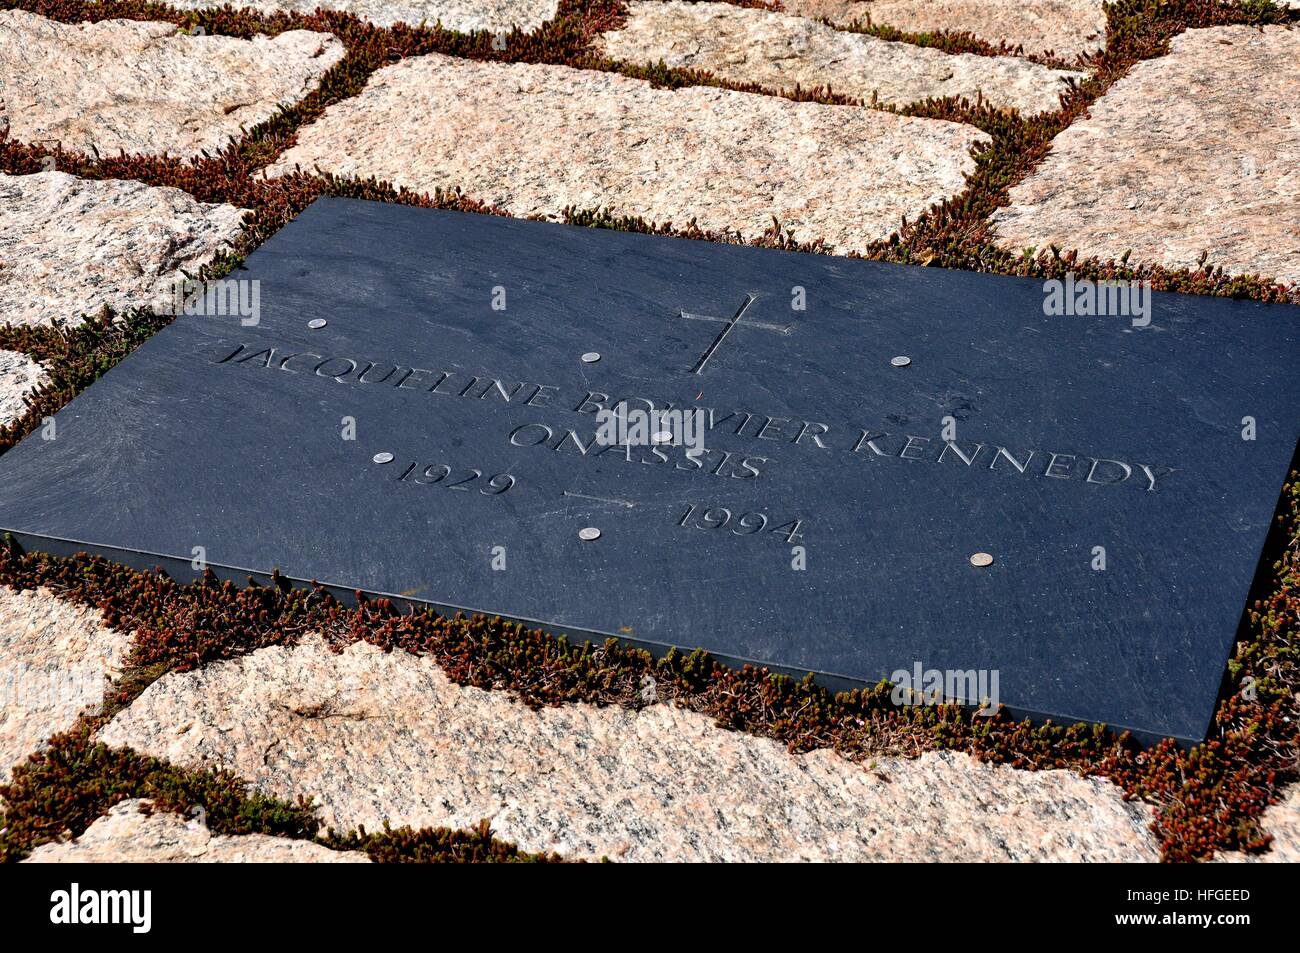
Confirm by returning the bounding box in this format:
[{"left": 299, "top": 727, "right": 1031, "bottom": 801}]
[{"left": 781, "top": 0, "right": 1106, "bottom": 61}]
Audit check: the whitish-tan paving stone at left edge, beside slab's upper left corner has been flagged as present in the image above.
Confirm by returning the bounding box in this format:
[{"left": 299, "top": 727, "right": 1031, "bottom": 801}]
[{"left": 0, "top": 172, "right": 243, "bottom": 325}]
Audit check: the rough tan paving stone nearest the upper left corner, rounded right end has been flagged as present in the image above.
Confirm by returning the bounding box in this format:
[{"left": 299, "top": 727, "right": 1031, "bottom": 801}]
[{"left": 0, "top": 10, "right": 345, "bottom": 156}]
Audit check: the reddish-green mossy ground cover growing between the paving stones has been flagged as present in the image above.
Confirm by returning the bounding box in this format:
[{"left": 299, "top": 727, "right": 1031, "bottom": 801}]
[{"left": 0, "top": 0, "right": 1300, "bottom": 861}]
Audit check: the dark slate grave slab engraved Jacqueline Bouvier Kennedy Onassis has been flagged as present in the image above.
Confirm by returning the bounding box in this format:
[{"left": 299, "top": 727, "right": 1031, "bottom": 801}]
[{"left": 0, "top": 199, "right": 1300, "bottom": 740}]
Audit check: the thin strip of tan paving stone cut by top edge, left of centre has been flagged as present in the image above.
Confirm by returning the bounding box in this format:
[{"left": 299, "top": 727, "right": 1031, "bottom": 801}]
[{"left": 163, "top": 0, "right": 559, "bottom": 33}]
